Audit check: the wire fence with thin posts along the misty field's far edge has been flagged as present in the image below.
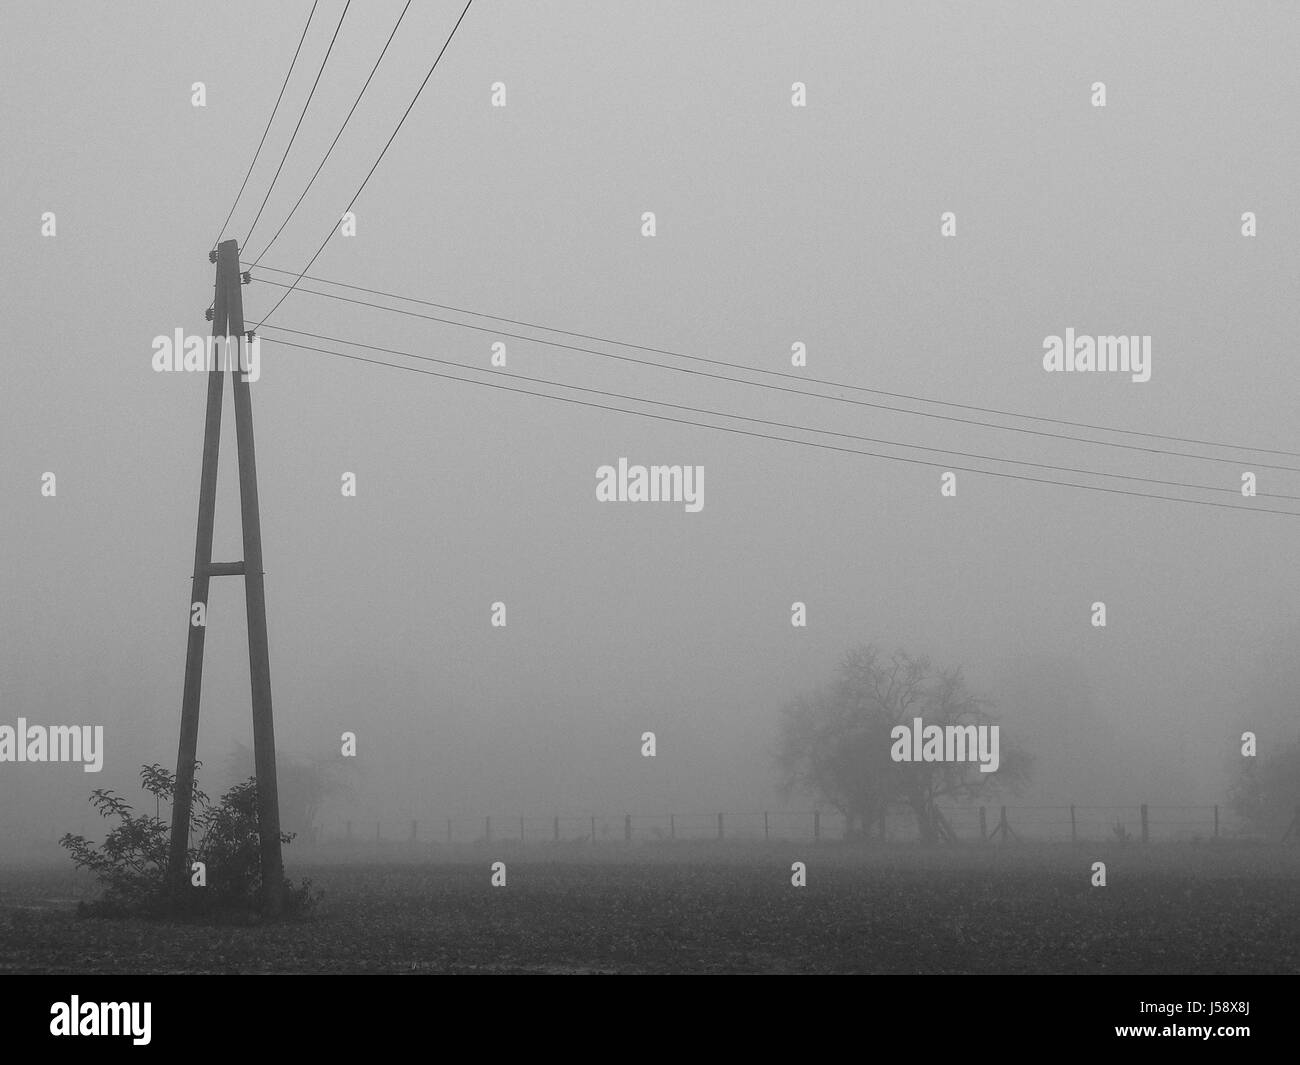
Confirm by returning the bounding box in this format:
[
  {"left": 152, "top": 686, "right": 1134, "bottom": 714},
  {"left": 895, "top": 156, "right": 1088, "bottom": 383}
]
[{"left": 312, "top": 804, "right": 1255, "bottom": 845}]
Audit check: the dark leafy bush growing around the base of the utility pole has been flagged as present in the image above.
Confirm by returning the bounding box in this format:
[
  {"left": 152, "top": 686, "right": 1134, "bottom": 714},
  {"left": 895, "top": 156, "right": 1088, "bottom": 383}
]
[{"left": 59, "top": 763, "right": 317, "bottom": 921}]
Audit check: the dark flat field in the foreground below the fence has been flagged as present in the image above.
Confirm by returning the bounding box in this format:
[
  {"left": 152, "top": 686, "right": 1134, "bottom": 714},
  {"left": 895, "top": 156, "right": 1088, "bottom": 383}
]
[{"left": 0, "top": 843, "right": 1300, "bottom": 974}]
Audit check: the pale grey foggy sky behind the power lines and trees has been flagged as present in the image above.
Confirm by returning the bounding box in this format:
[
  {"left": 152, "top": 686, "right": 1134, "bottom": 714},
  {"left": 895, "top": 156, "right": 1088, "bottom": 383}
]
[{"left": 0, "top": 0, "right": 1300, "bottom": 850}]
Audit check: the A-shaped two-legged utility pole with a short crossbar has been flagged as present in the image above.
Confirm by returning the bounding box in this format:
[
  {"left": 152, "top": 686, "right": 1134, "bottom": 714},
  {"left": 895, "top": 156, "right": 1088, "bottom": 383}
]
[{"left": 169, "top": 241, "right": 285, "bottom": 917}]
